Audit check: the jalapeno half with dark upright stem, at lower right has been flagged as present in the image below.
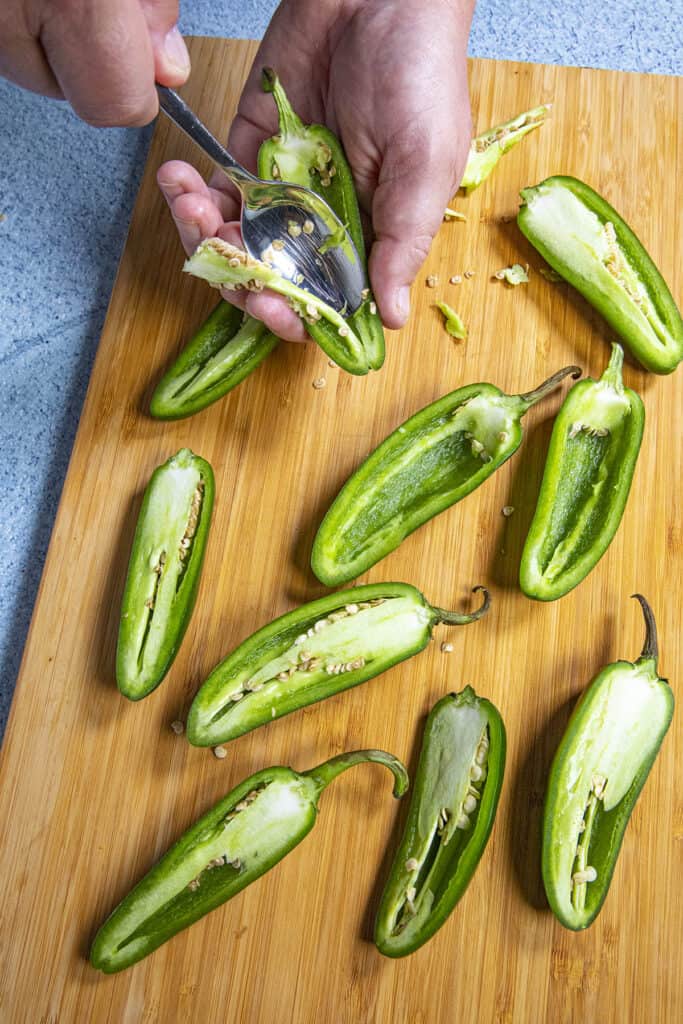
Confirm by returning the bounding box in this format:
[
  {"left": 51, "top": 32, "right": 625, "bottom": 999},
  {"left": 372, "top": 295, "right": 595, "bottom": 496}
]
[{"left": 542, "top": 594, "right": 674, "bottom": 931}]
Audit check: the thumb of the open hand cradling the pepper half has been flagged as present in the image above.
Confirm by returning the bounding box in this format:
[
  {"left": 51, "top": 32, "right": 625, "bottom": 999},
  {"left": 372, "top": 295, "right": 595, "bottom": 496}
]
[{"left": 369, "top": 124, "right": 469, "bottom": 329}]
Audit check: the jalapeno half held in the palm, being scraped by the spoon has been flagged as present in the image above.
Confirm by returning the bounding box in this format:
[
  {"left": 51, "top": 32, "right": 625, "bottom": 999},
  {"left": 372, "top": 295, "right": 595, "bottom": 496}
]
[{"left": 258, "top": 68, "right": 385, "bottom": 374}]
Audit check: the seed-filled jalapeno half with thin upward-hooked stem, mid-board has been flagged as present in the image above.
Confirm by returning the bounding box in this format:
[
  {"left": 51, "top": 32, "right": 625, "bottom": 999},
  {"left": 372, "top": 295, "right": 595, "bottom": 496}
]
[{"left": 187, "top": 583, "right": 489, "bottom": 746}]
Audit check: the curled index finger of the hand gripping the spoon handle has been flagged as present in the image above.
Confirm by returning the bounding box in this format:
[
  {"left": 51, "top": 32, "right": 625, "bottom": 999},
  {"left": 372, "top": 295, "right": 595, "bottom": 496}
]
[{"left": 40, "top": 0, "right": 159, "bottom": 126}]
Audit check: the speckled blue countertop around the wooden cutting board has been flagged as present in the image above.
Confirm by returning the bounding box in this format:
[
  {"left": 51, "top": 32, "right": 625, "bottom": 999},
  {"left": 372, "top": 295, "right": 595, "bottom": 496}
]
[{"left": 0, "top": 0, "right": 683, "bottom": 732}]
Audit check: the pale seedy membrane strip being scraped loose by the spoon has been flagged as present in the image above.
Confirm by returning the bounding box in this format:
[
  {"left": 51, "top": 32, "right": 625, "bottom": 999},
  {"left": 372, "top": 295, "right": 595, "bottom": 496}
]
[{"left": 183, "top": 238, "right": 370, "bottom": 374}]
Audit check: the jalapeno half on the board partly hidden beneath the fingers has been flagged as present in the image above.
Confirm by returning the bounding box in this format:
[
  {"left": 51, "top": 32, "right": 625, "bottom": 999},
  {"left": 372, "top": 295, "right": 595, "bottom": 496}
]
[{"left": 150, "top": 302, "right": 280, "bottom": 420}]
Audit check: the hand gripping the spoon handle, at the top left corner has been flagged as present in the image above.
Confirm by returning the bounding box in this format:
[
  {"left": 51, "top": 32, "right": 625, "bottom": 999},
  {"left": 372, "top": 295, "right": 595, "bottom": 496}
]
[{"left": 0, "top": 0, "right": 189, "bottom": 126}]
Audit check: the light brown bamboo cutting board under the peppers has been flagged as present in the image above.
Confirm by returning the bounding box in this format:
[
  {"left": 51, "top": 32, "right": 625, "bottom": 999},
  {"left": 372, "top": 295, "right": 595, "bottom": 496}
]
[{"left": 0, "top": 34, "right": 683, "bottom": 1024}]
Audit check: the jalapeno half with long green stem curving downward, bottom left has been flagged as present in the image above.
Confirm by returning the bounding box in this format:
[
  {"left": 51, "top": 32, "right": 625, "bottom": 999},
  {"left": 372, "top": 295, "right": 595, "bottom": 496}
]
[{"left": 90, "top": 750, "right": 408, "bottom": 974}]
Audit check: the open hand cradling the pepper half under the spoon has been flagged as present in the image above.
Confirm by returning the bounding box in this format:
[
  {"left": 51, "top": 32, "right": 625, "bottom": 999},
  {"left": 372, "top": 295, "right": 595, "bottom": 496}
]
[{"left": 158, "top": 0, "right": 474, "bottom": 341}]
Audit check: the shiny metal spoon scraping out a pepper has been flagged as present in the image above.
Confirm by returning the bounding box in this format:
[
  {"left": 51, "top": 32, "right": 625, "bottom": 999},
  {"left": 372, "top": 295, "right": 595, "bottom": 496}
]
[{"left": 157, "top": 85, "right": 366, "bottom": 312}]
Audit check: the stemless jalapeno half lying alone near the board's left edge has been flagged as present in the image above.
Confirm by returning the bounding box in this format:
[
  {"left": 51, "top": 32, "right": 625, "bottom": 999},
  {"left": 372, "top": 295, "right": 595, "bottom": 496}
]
[{"left": 116, "top": 449, "right": 214, "bottom": 700}]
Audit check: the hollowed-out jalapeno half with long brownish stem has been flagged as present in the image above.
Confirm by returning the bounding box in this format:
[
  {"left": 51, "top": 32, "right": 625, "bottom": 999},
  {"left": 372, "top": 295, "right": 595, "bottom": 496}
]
[{"left": 311, "top": 367, "right": 581, "bottom": 587}]
